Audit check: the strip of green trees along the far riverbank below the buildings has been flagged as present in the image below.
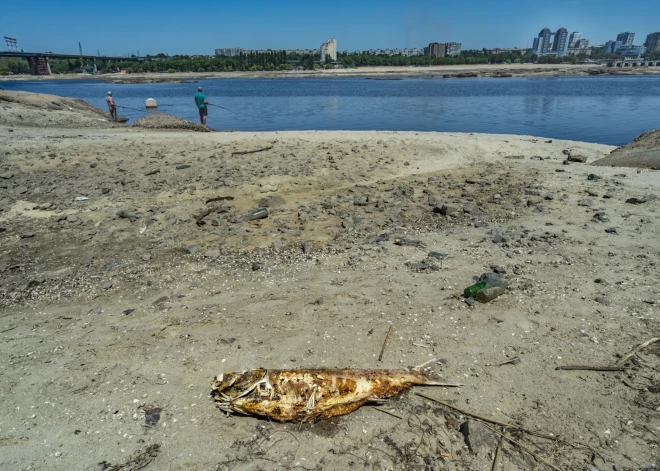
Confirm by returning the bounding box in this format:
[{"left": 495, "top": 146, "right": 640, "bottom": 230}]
[{"left": 0, "top": 48, "right": 660, "bottom": 75}]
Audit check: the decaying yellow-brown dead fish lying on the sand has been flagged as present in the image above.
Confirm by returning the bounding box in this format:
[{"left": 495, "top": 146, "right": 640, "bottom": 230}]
[{"left": 212, "top": 368, "right": 460, "bottom": 422}]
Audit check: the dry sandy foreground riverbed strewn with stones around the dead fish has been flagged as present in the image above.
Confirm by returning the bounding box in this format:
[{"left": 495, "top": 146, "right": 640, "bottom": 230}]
[{"left": 0, "top": 107, "right": 660, "bottom": 471}]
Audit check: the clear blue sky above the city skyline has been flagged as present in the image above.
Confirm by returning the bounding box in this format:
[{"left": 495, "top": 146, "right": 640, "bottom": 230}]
[{"left": 0, "top": 0, "right": 660, "bottom": 55}]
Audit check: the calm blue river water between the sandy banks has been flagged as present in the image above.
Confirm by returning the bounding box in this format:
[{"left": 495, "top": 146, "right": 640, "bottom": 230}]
[{"left": 0, "top": 76, "right": 660, "bottom": 145}]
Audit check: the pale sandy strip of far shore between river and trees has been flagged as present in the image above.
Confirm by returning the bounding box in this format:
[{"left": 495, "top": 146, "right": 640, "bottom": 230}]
[{"left": 0, "top": 64, "right": 660, "bottom": 84}]
